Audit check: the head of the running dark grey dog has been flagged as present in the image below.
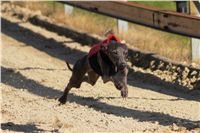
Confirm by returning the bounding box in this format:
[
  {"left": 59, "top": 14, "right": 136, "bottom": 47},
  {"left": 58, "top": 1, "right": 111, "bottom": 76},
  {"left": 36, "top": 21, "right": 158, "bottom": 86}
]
[{"left": 101, "top": 41, "right": 128, "bottom": 71}]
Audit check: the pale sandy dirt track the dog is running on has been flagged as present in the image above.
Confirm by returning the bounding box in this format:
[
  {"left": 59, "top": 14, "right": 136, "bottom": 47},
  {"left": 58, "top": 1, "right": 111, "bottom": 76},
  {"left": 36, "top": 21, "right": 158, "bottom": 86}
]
[{"left": 1, "top": 9, "right": 200, "bottom": 132}]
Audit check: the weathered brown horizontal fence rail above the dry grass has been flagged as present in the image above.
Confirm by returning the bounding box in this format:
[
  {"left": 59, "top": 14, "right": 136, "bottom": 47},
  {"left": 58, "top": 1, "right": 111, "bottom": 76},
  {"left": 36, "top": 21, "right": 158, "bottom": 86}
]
[{"left": 60, "top": 1, "right": 200, "bottom": 38}]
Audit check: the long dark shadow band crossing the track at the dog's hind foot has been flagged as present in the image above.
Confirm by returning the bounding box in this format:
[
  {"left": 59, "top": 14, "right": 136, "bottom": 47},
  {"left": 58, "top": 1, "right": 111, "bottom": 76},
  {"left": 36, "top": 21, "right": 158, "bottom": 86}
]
[{"left": 1, "top": 67, "right": 200, "bottom": 130}]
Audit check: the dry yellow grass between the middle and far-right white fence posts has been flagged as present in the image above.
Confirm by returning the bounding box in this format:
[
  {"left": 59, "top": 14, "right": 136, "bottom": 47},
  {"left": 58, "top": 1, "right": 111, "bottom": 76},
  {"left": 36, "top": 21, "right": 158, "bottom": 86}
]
[{"left": 120, "top": 26, "right": 191, "bottom": 63}]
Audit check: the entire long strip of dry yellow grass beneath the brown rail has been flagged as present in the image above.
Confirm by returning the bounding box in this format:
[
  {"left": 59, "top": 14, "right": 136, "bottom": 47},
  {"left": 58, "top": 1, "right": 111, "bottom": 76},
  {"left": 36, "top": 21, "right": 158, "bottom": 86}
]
[{"left": 14, "top": 2, "right": 198, "bottom": 64}]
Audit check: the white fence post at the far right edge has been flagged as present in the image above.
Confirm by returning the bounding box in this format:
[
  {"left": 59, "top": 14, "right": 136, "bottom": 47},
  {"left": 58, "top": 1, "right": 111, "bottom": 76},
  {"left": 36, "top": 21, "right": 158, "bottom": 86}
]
[{"left": 191, "top": 1, "right": 200, "bottom": 61}]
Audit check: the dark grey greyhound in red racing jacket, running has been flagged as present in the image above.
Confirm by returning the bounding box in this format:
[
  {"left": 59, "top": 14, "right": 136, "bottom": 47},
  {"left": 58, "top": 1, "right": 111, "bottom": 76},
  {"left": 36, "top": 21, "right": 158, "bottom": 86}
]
[{"left": 59, "top": 34, "right": 128, "bottom": 104}]
